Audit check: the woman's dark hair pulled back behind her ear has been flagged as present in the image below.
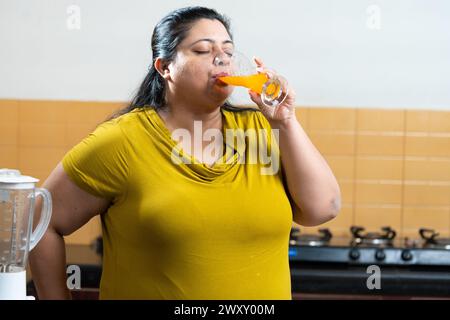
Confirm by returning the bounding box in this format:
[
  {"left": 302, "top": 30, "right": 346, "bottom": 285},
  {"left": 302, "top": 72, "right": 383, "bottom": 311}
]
[{"left": 112, "top": 7, "right": 248, "bottom": 118}]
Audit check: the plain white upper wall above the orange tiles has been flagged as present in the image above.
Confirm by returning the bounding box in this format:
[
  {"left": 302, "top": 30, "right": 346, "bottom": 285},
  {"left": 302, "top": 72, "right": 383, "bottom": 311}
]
[{"left": 0, "top": 0, "right": 450, "bottom": 110}]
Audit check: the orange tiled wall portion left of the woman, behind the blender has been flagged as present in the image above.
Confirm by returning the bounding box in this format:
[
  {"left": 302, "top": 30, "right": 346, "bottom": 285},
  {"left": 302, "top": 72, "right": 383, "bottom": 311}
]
[{"left": 0, "top": 100, "right": 122, "bottom": 243}]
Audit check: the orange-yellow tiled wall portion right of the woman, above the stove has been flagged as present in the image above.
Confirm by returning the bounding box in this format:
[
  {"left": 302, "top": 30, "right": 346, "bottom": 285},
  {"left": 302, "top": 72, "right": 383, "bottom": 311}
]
[{"left": 298, "top": 108, "right": 450, "bottom": 237}]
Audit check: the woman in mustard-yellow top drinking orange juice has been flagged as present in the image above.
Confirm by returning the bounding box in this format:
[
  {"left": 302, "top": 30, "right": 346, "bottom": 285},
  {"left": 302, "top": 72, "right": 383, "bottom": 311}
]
[{"left": 30, "top": 7, "right": 340, "bottom": 299}]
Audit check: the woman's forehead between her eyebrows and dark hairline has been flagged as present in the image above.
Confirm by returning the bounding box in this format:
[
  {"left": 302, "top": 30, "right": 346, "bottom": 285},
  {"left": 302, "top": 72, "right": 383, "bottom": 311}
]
[{"left": 183, "top": 19, "right": 231, "bottom": 45}]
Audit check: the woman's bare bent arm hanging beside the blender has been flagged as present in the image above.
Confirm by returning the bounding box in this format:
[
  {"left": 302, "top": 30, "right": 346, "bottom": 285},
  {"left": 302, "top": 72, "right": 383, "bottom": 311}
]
[{"left": 30, "top": 163, "right": 109, "bottom": 299}]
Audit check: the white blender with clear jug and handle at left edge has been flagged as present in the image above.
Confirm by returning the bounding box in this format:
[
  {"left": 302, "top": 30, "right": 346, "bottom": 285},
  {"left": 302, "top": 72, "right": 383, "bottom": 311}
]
[{"left": 0, "top": 169, "right": 52, "bottom": 300}]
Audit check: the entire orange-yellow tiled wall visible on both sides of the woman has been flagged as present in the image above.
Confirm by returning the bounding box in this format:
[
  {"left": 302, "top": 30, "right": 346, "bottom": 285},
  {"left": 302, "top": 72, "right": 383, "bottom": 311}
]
[{"left": 0, "top": 100, "right": 450, "bottom": 243}]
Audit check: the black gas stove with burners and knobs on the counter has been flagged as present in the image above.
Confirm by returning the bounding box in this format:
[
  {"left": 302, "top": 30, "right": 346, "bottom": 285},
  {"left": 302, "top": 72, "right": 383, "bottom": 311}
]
[{"left": 289, "top": 226, "right": 450, "bottom": 266}]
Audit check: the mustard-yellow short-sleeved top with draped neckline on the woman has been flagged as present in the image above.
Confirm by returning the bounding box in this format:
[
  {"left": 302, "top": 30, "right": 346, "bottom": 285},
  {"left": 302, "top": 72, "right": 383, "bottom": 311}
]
[{"left": 62, "top": 108, "right": 292, "bottom": 299}]
